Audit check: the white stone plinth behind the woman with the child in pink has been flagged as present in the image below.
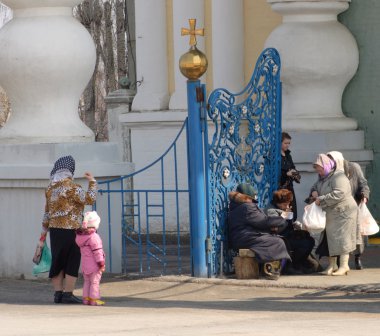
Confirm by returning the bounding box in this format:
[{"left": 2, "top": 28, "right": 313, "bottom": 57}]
[{"left": 0, "top": 143, "right": 133, "bottom": 277}]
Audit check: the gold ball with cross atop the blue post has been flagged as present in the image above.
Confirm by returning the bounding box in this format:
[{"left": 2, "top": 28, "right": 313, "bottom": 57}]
[{"left": 179, "top": 19, "right": 208, "bottom": 80}]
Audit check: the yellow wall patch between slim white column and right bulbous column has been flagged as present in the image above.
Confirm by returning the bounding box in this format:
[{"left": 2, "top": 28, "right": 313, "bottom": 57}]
[{"left": 244, "top": 0, "right": 282, "bottom": 83}]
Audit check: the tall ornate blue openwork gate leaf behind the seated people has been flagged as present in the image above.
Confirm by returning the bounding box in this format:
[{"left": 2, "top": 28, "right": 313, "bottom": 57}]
[{"left": 205, "top": 48, "right": 281, "bottom": 276}]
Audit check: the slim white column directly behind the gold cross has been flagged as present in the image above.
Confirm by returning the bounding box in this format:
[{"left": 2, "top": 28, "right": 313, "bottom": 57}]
[{"left": 169, "top": 0, "right": 208, "bottom": 110}]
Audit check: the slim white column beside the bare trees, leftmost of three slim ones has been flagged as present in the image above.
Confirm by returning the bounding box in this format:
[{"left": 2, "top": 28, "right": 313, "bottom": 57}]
[{"left": 132, "top": 0, "right": 169, "bottom": 111}]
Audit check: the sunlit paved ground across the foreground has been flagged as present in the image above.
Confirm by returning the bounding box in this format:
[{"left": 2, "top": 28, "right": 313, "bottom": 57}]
[{"left": 0, "top": 248, "right": 380, "bottom": 336}]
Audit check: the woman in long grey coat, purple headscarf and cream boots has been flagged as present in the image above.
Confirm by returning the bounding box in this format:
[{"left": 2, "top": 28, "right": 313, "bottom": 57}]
[{"left": 311, "top": 154, "right": 358, "bottom": 275}]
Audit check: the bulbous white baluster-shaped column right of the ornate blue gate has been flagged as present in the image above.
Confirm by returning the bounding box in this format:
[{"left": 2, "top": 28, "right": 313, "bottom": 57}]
[{"left": 266, "top": 0, "right": 359, "bottom": 131}]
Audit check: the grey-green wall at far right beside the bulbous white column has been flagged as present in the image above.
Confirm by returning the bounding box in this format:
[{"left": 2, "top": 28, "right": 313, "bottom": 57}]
[{"left": 339, "top": 0, "right": 380, "bottom": 219}]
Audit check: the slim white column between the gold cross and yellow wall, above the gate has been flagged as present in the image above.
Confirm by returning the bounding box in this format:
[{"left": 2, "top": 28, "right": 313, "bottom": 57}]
[{"left": 209, "top": 0, "right": 244, "bottom": 92}]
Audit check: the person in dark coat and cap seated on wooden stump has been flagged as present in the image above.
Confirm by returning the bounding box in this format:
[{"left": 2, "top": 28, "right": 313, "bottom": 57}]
[{"left": 228, "top": 183, "right": 290, "bottom": 280}]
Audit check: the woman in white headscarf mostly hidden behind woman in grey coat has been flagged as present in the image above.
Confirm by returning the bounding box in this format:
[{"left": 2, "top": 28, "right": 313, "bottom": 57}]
[{"left": 327, "top": 151, "right": 370, "bottom": 270}]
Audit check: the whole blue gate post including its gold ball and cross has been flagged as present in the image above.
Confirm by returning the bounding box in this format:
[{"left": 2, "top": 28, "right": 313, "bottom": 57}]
[{"left": 179, "top": 19, "right": 208, "bottom": 278}]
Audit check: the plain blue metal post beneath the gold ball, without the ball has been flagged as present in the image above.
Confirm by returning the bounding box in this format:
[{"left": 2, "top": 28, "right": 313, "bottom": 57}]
[{"left": 187, "top": 80, "right": 208, "bottom": 278}]
